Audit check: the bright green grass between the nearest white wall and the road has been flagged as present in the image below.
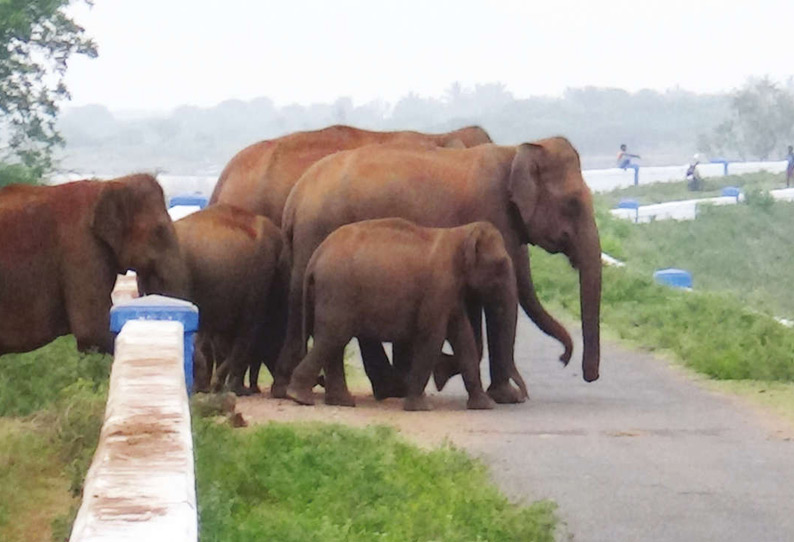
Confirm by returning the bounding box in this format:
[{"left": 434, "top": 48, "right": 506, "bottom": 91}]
[{"left": 194, "top": 419, "right": 555, "bottom": 542}]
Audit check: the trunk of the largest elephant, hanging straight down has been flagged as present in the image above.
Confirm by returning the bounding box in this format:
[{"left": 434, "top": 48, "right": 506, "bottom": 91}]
[{"left": 577, "top": 222, "right": 601, "bottom": 382}]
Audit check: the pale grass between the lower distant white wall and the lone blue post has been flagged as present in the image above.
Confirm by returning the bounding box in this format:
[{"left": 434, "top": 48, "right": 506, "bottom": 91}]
[{"left": 599, "top": 196, "right": 794, "bottom": 317}]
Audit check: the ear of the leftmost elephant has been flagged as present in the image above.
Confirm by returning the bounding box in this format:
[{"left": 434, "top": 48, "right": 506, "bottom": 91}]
[{"left": 91, "top": 181, "right": 132, "bottom": 267}]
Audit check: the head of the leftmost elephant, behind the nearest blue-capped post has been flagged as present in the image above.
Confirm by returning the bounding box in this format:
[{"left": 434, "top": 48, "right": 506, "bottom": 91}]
[{"left": 91, "top": 174, "right": 188, "bottom": 297}]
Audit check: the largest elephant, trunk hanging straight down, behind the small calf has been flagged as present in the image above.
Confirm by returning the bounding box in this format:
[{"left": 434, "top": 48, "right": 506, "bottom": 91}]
[{"left": 272, "top": 137, "right": 601, "bottom": 402}]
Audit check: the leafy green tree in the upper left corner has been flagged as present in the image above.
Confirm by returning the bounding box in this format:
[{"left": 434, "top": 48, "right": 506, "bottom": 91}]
[{"left": 0, "top": 0, "right": 97, "bottom": 174}]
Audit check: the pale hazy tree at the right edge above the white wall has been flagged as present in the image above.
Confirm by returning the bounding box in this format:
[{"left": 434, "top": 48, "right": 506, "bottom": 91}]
[{"left": 698, "top": 77, "right": 794, "bottom": 160}]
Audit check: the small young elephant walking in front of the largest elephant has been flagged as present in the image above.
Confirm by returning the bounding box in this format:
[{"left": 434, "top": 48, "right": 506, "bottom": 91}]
[{"left": 287, "top": 218, "right": 517, "bottom": 410}]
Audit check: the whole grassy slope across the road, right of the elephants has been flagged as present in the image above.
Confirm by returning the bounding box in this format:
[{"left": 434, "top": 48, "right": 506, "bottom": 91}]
[{"left": 532, "top": 173, "right": 794, "bottom": 419}]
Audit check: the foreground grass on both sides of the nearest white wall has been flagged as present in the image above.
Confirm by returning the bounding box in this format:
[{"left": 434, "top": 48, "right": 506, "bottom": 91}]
[{"left": 0, "top": 338, "right": 556, "bottom": 542}]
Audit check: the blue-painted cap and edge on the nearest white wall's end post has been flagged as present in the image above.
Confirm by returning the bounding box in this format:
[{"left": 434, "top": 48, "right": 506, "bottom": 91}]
[{"left": 110, "top": 295, "right": 199, "bottom": 394}]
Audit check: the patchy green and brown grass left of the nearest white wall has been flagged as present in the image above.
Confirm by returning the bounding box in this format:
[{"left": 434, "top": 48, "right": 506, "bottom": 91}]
[{"left": 0, "top": 337, "right": 111, "bottom": 542}]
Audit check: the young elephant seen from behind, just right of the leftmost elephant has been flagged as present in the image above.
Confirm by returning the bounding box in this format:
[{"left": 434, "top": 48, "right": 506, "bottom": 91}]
[{"left": 147, "top": 204, "right": 286, "bottom": 395}]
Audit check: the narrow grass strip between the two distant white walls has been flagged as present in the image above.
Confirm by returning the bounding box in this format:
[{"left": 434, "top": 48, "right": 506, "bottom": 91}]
[{"left": 598, "top": 171, "right": 786, "bottom": 208}]
